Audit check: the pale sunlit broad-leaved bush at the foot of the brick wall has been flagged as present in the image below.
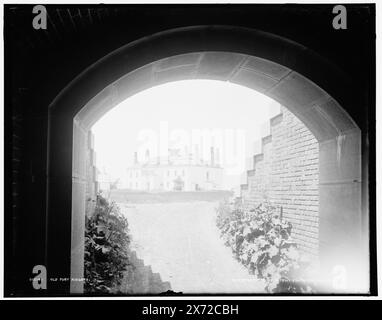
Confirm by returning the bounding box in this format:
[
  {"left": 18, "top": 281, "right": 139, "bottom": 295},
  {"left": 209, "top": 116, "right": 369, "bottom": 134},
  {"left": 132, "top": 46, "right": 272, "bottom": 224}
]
[{"left": 217, "top": 203, "right": 313, "bottom": 293}]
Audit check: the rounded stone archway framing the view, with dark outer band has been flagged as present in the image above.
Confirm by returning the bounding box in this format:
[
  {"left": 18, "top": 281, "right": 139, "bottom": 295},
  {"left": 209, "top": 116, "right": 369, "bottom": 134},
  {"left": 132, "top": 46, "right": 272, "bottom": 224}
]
[{"left": 47, "top": 26, "right": 368, "bottom": 293}]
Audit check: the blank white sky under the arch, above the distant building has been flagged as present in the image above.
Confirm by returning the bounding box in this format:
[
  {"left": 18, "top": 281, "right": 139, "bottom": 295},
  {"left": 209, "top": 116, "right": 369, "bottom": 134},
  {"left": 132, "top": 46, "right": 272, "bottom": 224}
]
[{"left": 92, "top": 80, "right": 278, "bottom": 185}]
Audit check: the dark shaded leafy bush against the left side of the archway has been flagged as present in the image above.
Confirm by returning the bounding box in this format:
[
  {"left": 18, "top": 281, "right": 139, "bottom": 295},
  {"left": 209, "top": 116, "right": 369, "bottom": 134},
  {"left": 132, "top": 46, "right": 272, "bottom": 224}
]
[{"left": 84, "top": 195, "right": 130, "bottom": 293}]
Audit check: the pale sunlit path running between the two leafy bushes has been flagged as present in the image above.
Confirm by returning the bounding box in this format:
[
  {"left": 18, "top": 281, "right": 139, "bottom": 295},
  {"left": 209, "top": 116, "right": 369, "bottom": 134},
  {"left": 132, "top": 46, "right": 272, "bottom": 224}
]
[{"left": 119, "top": 201, "right": 264, "bottom": 293}]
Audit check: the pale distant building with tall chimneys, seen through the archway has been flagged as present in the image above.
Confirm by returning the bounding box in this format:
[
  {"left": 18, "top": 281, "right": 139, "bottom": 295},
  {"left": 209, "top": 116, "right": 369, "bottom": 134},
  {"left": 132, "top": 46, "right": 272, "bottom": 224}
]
[{"left": 124, "top": 148, "right": 223, "bottom": 191}]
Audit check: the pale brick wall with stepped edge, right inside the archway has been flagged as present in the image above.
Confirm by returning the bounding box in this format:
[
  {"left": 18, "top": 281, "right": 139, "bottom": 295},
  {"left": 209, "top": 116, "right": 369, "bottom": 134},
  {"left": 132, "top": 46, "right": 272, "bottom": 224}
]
[{"left": 242, "top": 107, "right": 319, "bottom": 255}]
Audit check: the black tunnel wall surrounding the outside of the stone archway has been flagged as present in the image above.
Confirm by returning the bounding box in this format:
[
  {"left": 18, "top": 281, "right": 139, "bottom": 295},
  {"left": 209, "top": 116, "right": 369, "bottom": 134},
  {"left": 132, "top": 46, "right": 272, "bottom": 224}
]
[{"left": 4, "top": 5, "right": 375, "bottom": 296}]
